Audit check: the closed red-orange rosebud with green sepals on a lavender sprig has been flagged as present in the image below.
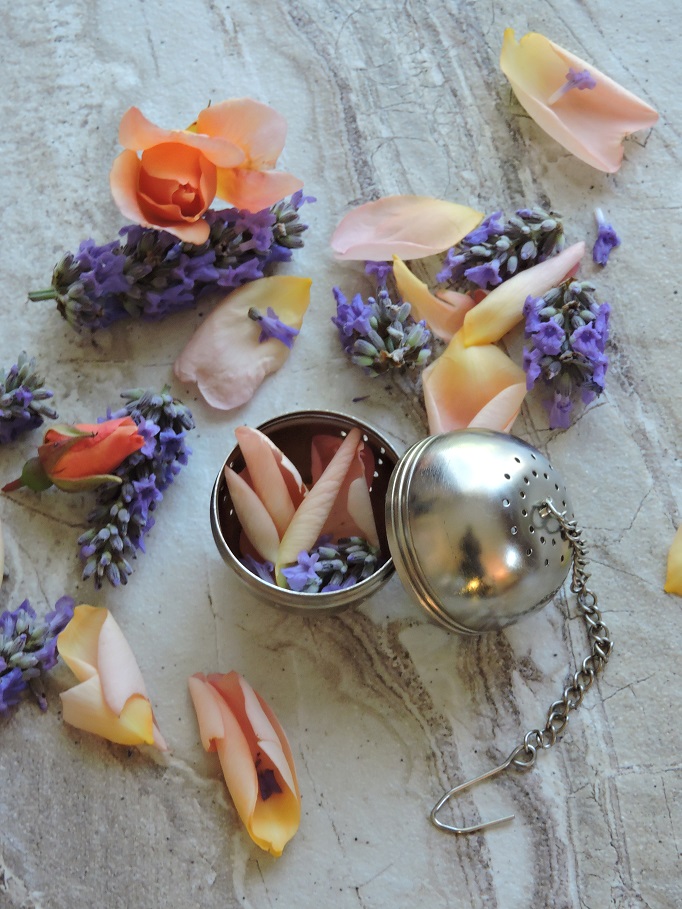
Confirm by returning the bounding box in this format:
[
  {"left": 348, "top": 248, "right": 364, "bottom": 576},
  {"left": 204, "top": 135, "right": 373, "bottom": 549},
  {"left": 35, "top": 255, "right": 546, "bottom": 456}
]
[{"left": 2, "top": 417, "right": 145, "bottom": 492}]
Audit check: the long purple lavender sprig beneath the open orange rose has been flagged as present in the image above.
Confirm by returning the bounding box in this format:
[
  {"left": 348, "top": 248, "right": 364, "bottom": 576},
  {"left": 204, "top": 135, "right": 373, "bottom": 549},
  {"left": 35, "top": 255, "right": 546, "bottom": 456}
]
[{"left": 29, "top": 191, "right": 314, "bottom": 331}]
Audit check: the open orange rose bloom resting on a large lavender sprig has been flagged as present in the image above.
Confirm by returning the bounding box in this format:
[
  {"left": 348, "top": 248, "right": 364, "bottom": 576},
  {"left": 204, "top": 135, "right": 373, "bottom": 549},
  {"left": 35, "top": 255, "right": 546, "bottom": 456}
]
[{"left": 110, "top": 98, "right": 303, "bottom": 243}]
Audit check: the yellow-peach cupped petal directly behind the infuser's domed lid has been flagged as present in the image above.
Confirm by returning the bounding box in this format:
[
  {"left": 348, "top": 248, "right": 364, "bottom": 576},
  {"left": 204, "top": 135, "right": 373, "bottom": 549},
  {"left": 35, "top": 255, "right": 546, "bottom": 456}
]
[{"left": 422, "top": 331, "right": 526, "bottom": 435}]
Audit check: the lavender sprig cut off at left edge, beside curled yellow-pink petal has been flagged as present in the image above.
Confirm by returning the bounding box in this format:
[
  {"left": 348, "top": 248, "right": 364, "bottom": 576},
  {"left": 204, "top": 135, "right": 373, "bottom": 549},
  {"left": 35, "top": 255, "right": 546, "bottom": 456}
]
[{"left": 0, "top": 597, "right": 74, "bottom": 714}]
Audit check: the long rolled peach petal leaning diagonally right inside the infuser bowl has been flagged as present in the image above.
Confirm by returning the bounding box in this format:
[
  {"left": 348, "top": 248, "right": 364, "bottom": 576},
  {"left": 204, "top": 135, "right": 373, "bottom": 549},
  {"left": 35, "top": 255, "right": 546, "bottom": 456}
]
[{"left": 275, "top": 427, "right": 364, "bottom": 586}]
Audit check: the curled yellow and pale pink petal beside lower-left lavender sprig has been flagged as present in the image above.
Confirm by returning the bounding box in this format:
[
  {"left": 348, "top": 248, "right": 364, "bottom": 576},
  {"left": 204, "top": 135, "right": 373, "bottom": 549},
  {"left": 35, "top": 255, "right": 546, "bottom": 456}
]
[{"left": 57, "top": 606, "right": 166, "bottom": 751}]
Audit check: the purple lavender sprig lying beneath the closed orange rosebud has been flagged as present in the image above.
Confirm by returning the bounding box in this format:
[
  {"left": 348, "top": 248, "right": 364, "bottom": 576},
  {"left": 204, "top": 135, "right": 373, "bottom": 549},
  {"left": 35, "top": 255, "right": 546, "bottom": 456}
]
[{"left": 78, "top": 386, "right": 194, "bottom": 589}]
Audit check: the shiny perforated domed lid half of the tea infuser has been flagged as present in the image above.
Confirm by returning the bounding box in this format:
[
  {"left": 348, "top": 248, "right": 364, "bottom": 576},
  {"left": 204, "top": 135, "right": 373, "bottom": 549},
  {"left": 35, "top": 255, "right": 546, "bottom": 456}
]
[{"left": 386, "top": 430, "right": 573, "bottom": 634}]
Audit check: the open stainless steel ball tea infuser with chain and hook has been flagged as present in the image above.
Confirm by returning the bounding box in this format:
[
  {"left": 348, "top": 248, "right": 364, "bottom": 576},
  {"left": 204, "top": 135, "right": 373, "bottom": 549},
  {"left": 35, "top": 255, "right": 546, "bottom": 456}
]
[{"left": 211, "top": 411, "right": 613, "bottom": 834}]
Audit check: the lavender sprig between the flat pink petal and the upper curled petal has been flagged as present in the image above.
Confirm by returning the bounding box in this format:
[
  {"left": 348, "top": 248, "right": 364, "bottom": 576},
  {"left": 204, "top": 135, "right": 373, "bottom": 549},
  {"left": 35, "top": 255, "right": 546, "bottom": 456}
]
[{"left": 437, "top": 208, "right": 564, "bottom": 289}]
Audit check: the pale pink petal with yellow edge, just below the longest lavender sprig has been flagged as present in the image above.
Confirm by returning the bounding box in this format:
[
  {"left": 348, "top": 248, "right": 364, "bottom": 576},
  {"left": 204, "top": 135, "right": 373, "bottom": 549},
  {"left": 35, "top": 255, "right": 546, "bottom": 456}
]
[{"left": 174, "top": 275, "right": 312, "bottom": 410}]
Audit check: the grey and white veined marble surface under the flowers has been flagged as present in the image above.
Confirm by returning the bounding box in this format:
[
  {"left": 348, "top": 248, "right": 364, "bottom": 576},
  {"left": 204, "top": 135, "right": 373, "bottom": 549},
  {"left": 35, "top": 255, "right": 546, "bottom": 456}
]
[{"left": 0, "top": 0, "right": 682, "bottom": 909}]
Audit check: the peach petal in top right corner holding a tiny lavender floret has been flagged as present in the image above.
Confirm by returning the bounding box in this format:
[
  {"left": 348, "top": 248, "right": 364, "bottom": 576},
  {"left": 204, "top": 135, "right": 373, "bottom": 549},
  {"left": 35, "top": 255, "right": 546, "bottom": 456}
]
[{"left": 500, "top": 28, "right": 658, "bottom": 173}]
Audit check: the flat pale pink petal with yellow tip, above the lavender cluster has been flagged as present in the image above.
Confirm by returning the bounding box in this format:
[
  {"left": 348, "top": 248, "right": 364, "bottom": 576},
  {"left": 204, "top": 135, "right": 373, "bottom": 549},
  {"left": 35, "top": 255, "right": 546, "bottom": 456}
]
[{"left": 331, "top": 196, "right": 483, "bottom": 262}]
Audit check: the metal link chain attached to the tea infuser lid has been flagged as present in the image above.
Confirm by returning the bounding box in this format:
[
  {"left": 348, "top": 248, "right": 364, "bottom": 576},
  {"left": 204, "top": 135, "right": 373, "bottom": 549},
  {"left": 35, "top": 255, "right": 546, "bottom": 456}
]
[{"left": 508, "top": 499, "right": 613, "bottom": 770}]
